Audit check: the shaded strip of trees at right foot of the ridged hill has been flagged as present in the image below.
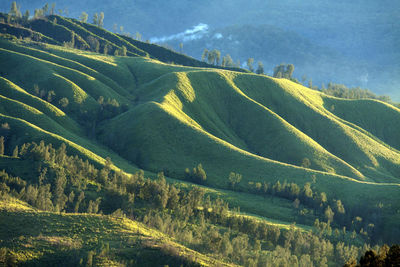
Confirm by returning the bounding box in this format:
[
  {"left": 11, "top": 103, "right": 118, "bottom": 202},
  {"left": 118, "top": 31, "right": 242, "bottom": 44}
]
[{"left": 249, "top": 180, "right": 381, "bottom": 242}]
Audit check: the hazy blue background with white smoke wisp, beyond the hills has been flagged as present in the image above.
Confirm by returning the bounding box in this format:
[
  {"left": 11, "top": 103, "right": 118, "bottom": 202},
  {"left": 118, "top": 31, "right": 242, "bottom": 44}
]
[{"left": 0, "top": 0, "right": 400, "bottom": 101}]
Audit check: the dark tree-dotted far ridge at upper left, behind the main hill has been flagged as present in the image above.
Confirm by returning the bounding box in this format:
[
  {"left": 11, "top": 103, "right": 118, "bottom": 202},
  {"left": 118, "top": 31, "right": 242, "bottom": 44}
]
[{"left": 0, "top": 13, "right": 246, "bottom": 72}]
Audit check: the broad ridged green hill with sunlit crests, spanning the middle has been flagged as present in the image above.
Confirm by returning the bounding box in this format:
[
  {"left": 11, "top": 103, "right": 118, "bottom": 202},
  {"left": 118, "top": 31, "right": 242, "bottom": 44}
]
[{"left": 0, "top": 37, "right": 400, "bottom": 237}]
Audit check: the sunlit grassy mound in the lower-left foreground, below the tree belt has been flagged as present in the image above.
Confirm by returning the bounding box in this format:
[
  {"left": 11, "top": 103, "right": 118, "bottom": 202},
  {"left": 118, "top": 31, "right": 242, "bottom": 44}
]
[{"left": 0, "top": 196, "right": 233, "bottom": 266}]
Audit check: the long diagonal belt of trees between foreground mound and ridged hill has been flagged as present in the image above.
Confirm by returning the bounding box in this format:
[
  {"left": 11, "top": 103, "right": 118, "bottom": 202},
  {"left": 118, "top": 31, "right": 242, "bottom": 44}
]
[{"left": 0, "top": 142, "right": 386, "bottom": 266}]
